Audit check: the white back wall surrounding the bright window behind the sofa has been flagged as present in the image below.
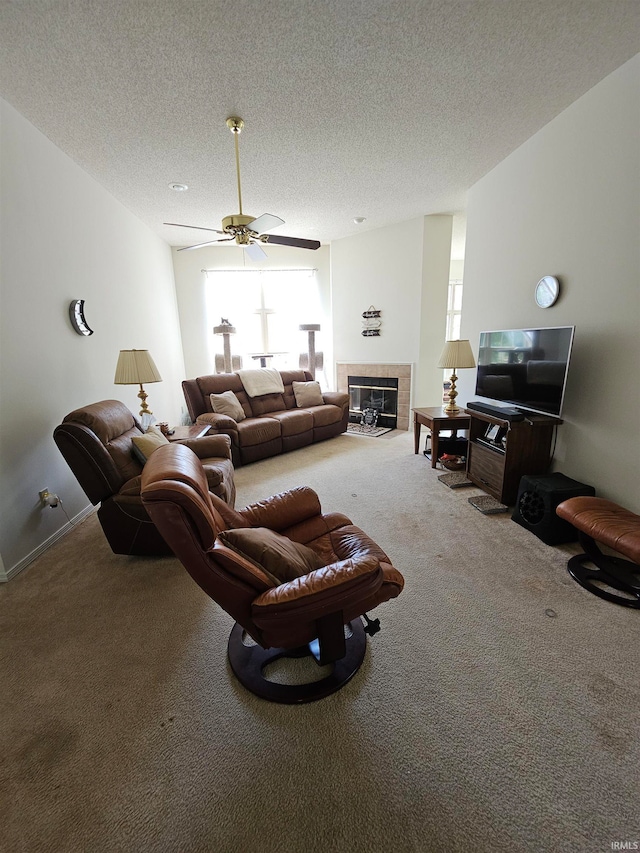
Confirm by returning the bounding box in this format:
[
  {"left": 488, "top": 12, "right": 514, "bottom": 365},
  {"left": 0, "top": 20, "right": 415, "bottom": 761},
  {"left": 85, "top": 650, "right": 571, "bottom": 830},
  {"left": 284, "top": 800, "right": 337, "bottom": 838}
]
[{"left": 173, "top": 241, "right": 332, "bottom": 381}]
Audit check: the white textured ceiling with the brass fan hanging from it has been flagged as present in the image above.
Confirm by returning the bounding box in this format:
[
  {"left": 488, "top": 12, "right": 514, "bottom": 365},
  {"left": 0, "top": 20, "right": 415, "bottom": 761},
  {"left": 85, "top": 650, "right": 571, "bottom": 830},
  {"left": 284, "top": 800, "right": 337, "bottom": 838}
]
[{"left": 0, "top": 0, "right": 640, "bottom": 256}]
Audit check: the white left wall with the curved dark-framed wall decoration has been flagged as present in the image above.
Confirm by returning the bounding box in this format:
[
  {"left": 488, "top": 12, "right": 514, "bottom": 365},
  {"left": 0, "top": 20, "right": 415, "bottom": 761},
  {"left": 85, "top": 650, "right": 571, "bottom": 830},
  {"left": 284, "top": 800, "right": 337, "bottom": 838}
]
[{"left": 0, "top": 101, "right": 184, "bottom": 575}]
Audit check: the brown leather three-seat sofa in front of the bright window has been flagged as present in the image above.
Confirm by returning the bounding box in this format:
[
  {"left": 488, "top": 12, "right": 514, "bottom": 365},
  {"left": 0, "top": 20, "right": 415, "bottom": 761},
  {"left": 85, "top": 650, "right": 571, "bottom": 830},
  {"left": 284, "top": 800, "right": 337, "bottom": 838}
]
[{"left": 182, "top": 370, "right": 349, "bottom": 467}]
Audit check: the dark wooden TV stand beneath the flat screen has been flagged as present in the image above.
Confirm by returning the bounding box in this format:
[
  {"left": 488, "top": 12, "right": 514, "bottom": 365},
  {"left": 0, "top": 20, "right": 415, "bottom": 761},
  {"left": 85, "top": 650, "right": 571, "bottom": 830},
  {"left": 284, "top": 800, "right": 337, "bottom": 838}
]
[{"left": 466, "top": 409, "right": 562, "bottom": 506}]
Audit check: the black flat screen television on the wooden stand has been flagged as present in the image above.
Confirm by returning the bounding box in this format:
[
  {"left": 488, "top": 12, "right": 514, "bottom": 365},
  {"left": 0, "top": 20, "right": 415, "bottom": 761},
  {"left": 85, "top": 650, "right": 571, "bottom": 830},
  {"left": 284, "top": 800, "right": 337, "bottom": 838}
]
[{"left": 476, "top": 326, "right": 575, "bottom": 417}]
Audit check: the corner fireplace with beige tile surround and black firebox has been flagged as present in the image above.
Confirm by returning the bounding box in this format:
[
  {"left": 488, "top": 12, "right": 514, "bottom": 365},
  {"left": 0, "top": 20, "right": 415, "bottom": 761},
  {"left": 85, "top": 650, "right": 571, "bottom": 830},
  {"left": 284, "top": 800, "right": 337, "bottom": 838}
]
[{"left": 336, "top": 361, "right": 412, "bottom": 430}]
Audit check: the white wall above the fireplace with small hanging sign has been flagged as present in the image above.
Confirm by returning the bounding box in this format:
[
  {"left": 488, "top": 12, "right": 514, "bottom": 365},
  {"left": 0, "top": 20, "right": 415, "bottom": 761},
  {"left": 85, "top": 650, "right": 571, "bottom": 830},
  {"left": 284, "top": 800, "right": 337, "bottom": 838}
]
[{"left": 331, "top": 214, "right": 452, "bottom": 406}]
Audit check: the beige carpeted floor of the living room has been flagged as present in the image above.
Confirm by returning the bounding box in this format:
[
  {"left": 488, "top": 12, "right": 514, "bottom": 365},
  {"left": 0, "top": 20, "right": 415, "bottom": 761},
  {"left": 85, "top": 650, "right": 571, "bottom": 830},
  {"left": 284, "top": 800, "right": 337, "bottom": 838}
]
[{"left": 0, "top": 432, "right": 640, "bottom": 853}]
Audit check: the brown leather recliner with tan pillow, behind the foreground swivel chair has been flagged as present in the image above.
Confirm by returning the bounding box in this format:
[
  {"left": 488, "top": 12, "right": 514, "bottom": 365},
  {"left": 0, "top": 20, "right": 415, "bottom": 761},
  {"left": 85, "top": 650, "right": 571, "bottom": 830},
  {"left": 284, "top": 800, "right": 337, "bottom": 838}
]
[{"left": 53, "top": 400, "right": 236, "bottom": 556}]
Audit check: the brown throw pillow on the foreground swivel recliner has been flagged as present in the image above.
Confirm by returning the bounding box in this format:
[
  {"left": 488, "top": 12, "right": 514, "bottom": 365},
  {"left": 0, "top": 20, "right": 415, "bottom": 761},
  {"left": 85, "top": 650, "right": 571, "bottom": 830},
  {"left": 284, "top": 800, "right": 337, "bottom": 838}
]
[{"left": 218, "top": 527, "right": 324, "bottom": 584}]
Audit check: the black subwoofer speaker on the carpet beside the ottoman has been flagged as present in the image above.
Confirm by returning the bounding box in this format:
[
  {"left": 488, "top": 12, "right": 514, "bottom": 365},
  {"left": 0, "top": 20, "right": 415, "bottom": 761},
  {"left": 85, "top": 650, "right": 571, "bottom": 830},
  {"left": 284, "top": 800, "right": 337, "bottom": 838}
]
[{"left": 511, "top": 473, "right": 596, "bottom": 545}]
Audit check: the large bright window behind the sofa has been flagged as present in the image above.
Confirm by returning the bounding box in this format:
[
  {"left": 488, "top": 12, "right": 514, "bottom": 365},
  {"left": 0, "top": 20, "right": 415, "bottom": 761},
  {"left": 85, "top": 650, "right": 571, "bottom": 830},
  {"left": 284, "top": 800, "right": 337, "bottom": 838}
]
[{"left": 207, "top": 270, "right": 321, "bottom": 370}]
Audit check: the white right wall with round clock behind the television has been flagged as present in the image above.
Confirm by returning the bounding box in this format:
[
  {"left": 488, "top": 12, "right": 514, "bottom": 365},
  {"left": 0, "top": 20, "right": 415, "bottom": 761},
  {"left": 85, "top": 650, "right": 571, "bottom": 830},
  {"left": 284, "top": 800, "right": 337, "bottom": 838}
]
[{"left": 458, "top": 54, "right": 640, "bottom": 512}]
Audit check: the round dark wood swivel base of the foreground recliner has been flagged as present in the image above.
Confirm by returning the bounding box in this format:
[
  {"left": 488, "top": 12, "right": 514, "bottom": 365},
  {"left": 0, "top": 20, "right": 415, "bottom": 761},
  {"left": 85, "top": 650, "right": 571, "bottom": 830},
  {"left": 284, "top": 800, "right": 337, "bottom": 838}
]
[{"left": 227, "top": 619, "right": 367, "bottom": 705}]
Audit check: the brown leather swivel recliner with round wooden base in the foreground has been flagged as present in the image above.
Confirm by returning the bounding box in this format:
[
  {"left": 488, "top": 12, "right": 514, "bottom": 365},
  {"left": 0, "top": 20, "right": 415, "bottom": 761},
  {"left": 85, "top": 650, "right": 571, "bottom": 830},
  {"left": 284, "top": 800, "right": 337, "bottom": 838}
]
[{"left": 142, "top": 445, "right": 404, "bottom": 704}]
